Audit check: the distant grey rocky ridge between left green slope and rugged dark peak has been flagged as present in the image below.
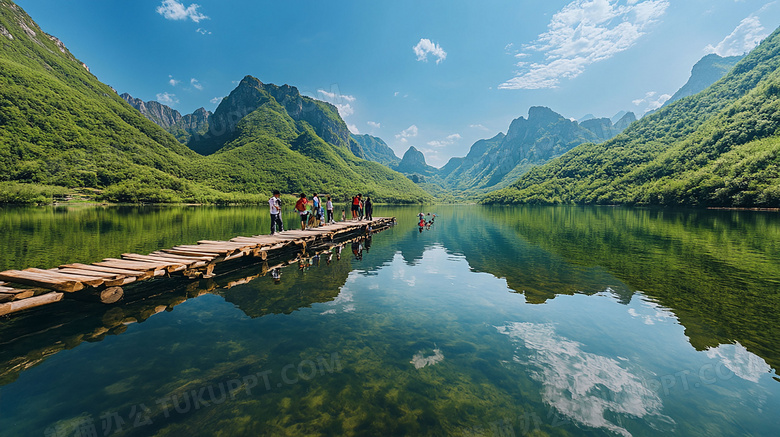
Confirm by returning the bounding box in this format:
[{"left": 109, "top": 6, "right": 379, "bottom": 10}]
[{"left": 119, "top": 93, "right": 211, "bottom": 144}]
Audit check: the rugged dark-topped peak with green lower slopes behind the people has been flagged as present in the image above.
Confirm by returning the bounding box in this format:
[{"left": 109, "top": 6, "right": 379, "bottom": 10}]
[{"left": 184, "top": 76, "right": 431, "bottom": 202}]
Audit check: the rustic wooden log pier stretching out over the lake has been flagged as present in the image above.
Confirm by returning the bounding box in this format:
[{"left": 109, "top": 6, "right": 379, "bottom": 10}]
[{"left": 0, "top": 217, "right": 395, "bottom": 316}]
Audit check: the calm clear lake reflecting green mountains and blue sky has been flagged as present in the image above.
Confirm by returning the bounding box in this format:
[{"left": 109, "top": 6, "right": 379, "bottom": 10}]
[{"left": 0, "top": 205, "right": 780, "bottom": 436}]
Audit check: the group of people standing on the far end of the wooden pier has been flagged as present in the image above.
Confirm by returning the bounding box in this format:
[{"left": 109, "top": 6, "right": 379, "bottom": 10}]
[{"left": 268, "top": 190, "right": 374, "bottom": 235}]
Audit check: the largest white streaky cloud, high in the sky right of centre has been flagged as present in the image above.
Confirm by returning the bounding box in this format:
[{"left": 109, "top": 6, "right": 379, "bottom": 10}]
[{"left": 499, "top": 0, "right": 669, "bottom": 89}]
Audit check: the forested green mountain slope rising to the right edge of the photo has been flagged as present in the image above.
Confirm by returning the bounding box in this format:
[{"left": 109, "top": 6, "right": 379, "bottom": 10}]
[{"left": 484, "top": 29, "right": 780, "bottom": 207}]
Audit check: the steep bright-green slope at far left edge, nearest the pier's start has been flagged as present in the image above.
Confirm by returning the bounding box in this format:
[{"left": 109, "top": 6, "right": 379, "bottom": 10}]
[{"left": 0, "top": 0, "right": 210, "bottom": 200}]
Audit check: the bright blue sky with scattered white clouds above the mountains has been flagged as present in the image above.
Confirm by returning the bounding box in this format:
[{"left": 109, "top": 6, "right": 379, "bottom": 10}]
[{"left": 17, "top": 0, "right": 780, "bottom": 167}]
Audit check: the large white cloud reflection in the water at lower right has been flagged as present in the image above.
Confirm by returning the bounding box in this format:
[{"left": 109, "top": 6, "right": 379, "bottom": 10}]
[{"left": 496, "top": 323, "right": 673, "bottom": 436}]
